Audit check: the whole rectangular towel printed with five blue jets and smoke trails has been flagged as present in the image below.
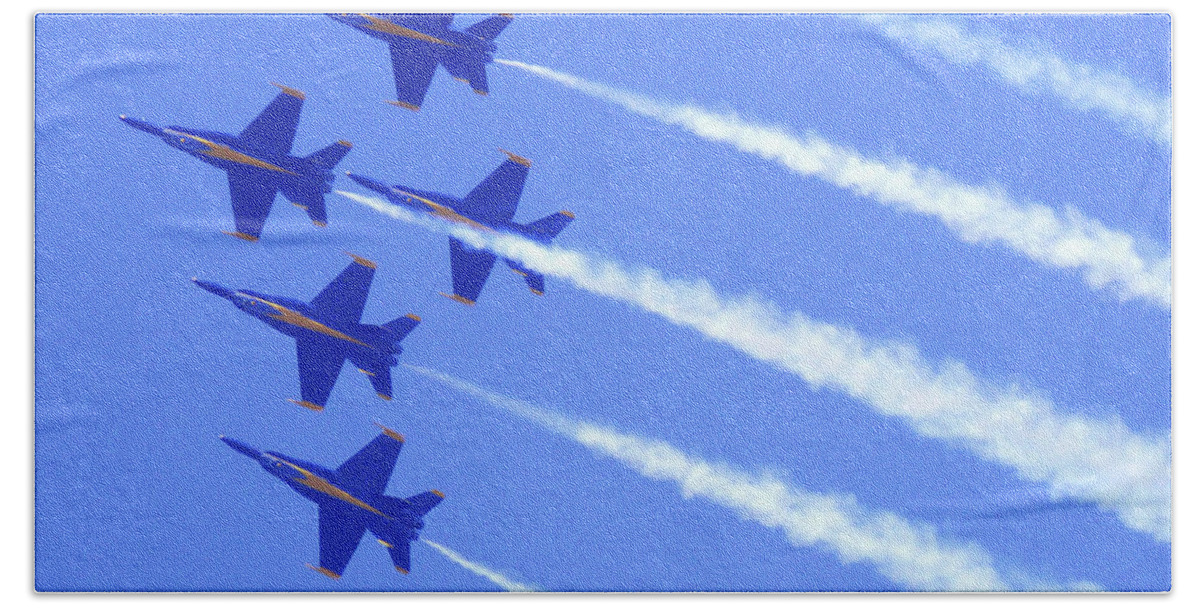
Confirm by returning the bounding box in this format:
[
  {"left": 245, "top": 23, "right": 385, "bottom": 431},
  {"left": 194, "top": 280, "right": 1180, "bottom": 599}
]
[{"left": 35, "top": 13, "right": 1172, "bottom": 591}]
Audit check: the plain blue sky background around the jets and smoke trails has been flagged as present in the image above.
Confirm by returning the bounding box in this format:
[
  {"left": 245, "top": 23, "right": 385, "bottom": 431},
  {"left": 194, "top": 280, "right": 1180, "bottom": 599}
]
[{"left": 35, "top": 16, "right": 1171, "bottom": 590}]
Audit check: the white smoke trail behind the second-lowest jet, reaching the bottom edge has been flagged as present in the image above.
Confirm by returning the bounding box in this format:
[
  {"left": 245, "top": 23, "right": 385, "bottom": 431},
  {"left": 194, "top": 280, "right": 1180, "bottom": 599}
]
[{"left": 406, "top": 363, "right": 1094, "bottom": 591}]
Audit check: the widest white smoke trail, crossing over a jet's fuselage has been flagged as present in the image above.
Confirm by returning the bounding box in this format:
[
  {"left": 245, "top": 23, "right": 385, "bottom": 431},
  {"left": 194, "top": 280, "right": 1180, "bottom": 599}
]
[{"left": 338, "top": 191, "right": 1171, "bottom": 542}]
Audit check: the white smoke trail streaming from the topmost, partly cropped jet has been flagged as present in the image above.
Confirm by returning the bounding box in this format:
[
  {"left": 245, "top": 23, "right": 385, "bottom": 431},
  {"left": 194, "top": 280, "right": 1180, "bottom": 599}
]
[{"left": 496, "top": 59, "right": 1171, "bottom": 308}]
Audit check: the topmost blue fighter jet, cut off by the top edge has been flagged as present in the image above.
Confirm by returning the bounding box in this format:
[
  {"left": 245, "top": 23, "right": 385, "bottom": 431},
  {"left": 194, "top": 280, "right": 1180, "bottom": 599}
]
[{"left": 330, "top": 13, "right": 512, "bottom": 112}]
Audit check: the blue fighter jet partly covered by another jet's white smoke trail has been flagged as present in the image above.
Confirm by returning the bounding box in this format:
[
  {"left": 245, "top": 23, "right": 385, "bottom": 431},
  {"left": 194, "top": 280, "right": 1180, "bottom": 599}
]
[{"left": 346, "top": 150, "right": 575, "bottom": 306}]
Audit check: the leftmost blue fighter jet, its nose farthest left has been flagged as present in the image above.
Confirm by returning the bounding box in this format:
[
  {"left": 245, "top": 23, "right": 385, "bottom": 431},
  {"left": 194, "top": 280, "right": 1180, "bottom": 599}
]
[{"left": 121, "top": 83, "right": 350, "bottom": 242}]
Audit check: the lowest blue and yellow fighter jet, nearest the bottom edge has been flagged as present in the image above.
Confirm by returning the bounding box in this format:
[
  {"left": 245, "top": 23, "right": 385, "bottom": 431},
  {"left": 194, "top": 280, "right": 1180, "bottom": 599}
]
[{"left": 221, "top": 425, "right": 445, "bottom": 579}]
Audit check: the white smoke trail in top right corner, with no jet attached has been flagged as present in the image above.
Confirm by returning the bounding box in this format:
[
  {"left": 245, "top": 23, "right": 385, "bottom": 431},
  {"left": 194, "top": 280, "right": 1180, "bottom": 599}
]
[{"left": 860, "top": 14, "right": 1171, "bottom": 144}]
